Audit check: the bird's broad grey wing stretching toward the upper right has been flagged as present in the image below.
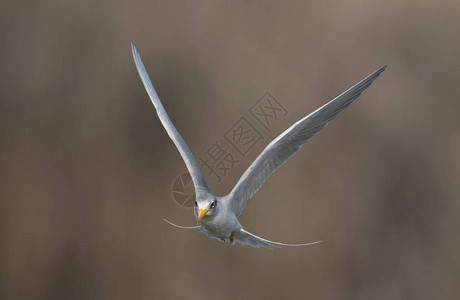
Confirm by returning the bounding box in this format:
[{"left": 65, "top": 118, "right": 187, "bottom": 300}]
[{"left": 225, "top": 66, "right": 386, "bottom": 216}]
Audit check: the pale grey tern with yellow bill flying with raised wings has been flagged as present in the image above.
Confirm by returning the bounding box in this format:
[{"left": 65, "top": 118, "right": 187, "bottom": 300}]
[{"left": 131, "top": 43, "right": 386, "bottom": 249}]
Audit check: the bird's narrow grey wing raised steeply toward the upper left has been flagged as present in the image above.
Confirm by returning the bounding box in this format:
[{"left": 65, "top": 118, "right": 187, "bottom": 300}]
[{"left": 131, "top": 43, "right": 209, "bottom": 195}]
